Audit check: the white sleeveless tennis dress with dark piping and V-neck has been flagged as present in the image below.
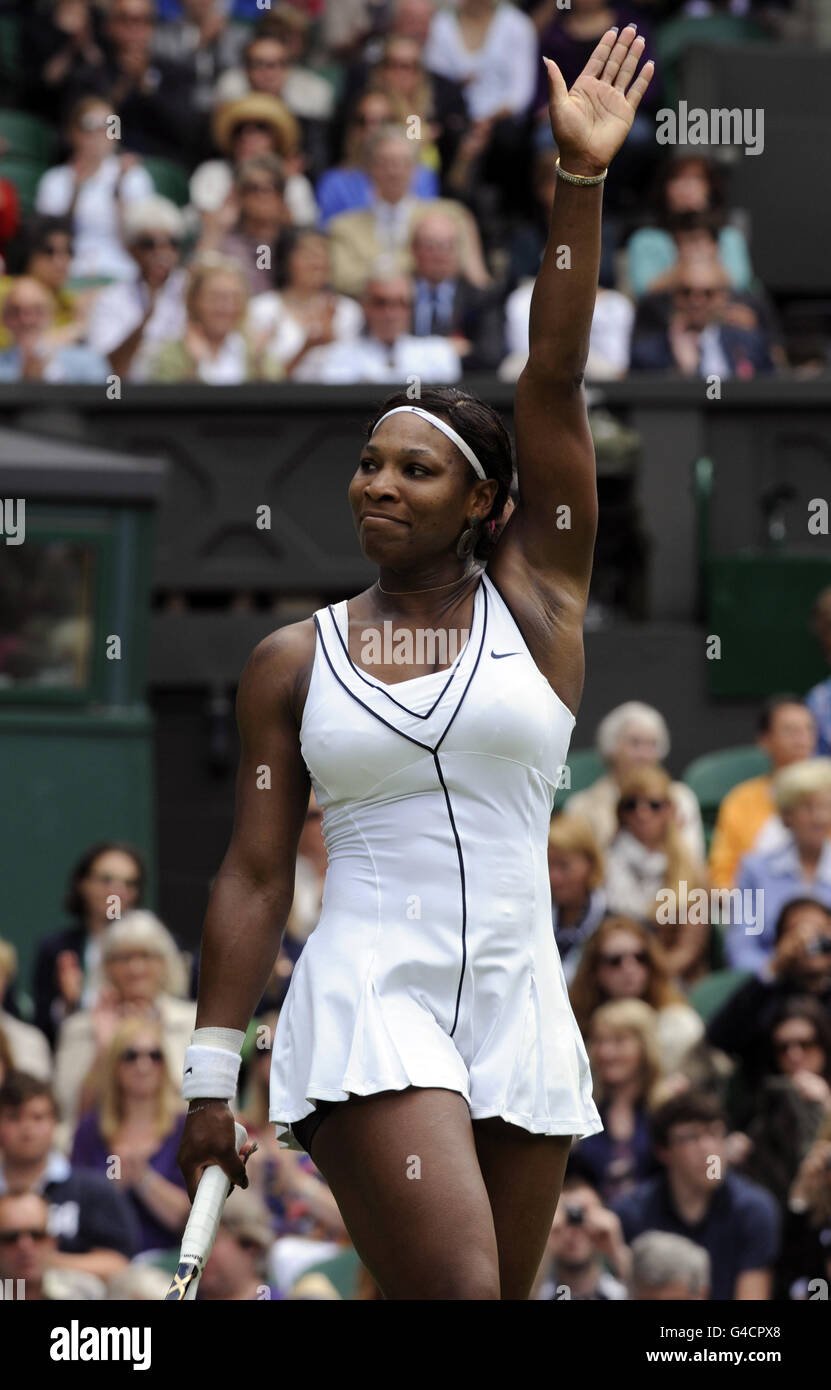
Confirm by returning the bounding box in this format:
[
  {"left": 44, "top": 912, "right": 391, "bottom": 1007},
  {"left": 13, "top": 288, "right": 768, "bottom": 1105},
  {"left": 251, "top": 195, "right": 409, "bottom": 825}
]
[{"left": 270, "top": 574, "right": 603, "bottom": 1148}]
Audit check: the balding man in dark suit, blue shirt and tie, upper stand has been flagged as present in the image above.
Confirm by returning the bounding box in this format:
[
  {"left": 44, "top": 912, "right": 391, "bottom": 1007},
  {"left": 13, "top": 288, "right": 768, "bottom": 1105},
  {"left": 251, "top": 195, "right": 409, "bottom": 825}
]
[{"left": 413, "top": 211, "right": 504, "bottom": 371}]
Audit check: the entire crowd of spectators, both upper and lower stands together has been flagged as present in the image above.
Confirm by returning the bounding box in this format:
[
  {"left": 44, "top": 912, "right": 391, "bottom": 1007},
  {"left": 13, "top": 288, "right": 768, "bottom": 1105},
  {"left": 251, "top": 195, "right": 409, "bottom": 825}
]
[{"left": 0, "top": 0, "right": 831, "bottom": 1301}]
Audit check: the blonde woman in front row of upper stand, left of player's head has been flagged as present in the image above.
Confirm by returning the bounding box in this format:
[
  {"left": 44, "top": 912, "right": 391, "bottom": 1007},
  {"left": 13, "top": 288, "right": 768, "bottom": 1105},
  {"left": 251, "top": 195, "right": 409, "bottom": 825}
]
[{"left": 147, "top": 252, "right": 283, "bottom": 386}]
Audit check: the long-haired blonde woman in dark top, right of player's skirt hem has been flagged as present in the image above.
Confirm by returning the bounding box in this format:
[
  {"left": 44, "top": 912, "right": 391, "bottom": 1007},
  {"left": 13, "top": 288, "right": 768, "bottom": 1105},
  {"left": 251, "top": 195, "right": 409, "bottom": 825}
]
[{"left": 573, "top": 999, "right": 663, "bottom": 1202}]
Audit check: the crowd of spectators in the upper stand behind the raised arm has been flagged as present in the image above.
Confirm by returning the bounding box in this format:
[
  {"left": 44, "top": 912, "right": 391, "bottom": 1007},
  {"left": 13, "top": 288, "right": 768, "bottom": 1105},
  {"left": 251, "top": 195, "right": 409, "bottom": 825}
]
[{"left": 0, "top": 0, "right": 828, "bottom": 385}]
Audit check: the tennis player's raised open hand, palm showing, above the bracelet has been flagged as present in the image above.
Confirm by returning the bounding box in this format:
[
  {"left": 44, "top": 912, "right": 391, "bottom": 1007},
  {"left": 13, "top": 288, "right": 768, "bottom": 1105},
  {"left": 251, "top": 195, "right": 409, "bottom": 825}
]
[{"left": 545, "top": 24, "right": 655, "bottom": 174}]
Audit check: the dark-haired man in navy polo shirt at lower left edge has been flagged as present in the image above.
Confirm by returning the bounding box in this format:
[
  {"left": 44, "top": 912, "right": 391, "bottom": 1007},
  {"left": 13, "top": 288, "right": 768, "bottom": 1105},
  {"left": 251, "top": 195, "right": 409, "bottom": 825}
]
[{"left": 0, "top": 1072, "right": 139, "bottom": 1279}]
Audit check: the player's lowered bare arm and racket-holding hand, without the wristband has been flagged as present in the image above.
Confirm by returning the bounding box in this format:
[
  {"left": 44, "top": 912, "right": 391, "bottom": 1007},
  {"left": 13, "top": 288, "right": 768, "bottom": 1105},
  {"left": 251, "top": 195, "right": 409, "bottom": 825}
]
[{"left": 179, "top": 624, "right": 314, "bottom": 1198}]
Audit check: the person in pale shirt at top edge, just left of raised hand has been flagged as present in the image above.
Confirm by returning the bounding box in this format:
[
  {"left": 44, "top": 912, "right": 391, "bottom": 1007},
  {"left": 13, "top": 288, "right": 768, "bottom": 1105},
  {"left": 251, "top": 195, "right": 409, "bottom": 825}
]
[{"left": 424, "top": 0, "right": 539, "bottom": 121}]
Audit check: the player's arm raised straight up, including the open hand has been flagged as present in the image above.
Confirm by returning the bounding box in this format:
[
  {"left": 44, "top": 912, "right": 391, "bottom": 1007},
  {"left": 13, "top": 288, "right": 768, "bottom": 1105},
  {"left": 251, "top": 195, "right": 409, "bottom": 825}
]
[{"left": 491, "top": 25, "right": 653, "bottom": 607}]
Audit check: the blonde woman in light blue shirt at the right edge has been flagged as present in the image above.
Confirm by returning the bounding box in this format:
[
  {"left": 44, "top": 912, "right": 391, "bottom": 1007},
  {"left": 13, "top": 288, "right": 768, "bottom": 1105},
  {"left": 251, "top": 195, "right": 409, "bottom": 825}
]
[{"left": 727, "top": 758, "right": 831, "bottom": 973}]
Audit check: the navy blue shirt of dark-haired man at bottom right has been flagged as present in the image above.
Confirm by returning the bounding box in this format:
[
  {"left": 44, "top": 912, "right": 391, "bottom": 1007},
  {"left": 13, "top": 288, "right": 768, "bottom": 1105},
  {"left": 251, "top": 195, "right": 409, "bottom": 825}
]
[{"left": 613, "top": 1172, "right": 781, "bottom": 1301}]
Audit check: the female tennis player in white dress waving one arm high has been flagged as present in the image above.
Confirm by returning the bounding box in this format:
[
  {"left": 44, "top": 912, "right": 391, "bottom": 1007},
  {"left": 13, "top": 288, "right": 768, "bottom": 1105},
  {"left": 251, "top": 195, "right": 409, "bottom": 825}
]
[{"left": 179, "top": 25, "right": 653, "bottom": 1300}]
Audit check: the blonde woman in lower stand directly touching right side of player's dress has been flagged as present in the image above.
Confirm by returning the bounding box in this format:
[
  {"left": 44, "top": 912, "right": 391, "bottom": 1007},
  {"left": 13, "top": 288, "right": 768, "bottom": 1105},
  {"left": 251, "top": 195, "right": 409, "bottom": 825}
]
[{"left": 549, "top": 816, "right": 607, "bottom": 983}]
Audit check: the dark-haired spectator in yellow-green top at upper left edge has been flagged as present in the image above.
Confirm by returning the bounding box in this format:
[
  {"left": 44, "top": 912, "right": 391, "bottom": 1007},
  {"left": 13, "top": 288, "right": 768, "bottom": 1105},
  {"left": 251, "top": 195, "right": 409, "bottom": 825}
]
[{"left": 0, "top": 214, "right": 89, "bottom": 350}]
